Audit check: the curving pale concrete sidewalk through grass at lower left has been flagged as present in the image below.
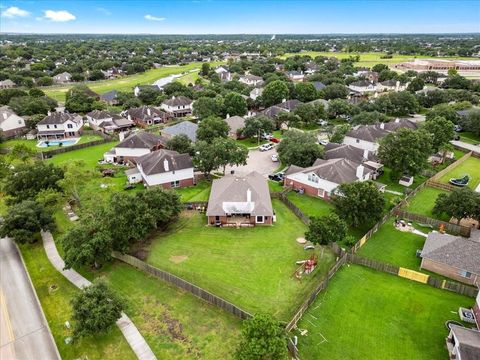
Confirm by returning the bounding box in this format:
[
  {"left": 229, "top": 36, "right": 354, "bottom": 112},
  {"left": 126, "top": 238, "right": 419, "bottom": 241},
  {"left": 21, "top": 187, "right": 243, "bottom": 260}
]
[{"left": 42, "top": 232, "right": 156, "bottom": 360}]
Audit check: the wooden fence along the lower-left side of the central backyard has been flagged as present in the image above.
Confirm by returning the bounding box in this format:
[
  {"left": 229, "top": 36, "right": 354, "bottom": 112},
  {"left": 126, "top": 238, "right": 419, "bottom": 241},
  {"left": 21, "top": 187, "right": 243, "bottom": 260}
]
[{"left": 112, "top": 251, "right": 252, "bottom": 319}]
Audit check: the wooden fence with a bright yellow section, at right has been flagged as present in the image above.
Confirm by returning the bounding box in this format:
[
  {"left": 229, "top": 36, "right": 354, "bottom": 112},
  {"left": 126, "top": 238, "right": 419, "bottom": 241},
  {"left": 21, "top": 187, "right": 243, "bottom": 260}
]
[{"left": 347, "top": 254, "right": 478, "bottom": 297}]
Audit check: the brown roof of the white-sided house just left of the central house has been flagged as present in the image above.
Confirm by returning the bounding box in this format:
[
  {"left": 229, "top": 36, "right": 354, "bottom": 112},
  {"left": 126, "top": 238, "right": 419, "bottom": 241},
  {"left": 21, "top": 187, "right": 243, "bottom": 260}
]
[{"left": 136, "top": 149, "right": 193, "bottom": 175}]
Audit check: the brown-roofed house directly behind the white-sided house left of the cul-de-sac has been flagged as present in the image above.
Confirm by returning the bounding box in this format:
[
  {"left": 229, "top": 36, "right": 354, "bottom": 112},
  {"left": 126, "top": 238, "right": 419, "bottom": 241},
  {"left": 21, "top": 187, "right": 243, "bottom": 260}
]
[{"left": 103, "top": 131, "right": 167, "bottom": 163}]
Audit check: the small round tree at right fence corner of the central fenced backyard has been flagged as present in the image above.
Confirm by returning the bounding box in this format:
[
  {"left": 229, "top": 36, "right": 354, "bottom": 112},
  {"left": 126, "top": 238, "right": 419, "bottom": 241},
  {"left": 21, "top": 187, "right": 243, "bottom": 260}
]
[{"left": 305, "top": 214, "right": 348, "bottom": 245}]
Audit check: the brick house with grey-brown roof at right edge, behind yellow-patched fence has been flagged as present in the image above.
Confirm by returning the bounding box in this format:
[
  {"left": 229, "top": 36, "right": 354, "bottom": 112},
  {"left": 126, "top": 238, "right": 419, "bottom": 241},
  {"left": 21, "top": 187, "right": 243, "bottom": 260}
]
[{"left": 420, "top": 232, "right": 480, "bottom": 286}]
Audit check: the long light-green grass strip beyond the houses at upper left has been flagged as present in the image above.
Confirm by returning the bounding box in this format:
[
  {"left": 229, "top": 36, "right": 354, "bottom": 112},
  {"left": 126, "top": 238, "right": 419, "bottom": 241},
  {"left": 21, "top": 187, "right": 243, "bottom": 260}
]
[{"left": 42, "top": 62, "right": 222, "bottom": 102}]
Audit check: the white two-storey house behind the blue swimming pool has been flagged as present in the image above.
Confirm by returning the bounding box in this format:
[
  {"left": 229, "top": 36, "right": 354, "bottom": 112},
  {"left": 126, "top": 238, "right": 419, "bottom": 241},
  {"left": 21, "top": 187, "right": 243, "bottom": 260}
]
[{"left": 37, "top": 112, "right": 83, "bottom": 140}]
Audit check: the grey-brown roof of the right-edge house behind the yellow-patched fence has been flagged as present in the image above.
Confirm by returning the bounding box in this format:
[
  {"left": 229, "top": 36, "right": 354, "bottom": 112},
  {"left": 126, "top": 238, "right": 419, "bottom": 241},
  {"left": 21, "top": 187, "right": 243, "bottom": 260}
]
[{"left": 421, "top": 232, "right": 480, "bottom": 275}]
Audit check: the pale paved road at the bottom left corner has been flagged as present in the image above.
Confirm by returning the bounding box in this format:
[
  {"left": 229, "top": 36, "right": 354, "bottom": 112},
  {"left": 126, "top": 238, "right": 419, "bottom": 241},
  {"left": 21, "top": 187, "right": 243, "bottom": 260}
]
[{"left": 0, "top": 239, "right": 60, "bottom": 360}]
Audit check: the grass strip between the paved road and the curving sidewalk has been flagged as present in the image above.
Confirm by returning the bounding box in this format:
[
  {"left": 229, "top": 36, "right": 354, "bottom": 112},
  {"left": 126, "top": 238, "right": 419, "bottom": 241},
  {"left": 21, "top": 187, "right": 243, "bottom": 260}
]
[{"left": 21, "top": 243, "right": 136, "bottom": 359}]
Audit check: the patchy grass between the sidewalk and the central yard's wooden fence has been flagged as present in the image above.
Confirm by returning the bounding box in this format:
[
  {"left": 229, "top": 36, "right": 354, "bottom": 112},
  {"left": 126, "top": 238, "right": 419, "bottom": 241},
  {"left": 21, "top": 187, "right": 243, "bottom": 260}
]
[{"left": 85, "top": 262, "right": 241, "bottom": 359}]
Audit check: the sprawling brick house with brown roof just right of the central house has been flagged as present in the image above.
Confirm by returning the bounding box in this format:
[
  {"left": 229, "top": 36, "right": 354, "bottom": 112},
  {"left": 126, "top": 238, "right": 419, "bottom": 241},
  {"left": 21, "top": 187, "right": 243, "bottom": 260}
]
[{"left": 284, "top": 158, "right": 375, "bottom": 200}]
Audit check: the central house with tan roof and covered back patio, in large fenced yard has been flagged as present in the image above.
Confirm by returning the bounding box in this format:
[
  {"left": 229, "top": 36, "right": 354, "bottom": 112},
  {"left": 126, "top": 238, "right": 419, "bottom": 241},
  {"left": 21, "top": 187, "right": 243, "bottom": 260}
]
[{"left": 207, "top": 171, "right": 275, "bottom": 227}]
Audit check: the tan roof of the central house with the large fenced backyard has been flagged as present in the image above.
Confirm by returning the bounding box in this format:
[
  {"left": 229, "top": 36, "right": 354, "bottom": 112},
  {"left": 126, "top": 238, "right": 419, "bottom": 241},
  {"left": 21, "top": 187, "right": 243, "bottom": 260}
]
[{"left": 207, "top": 171, "right": 273, "bottom": 216}]
